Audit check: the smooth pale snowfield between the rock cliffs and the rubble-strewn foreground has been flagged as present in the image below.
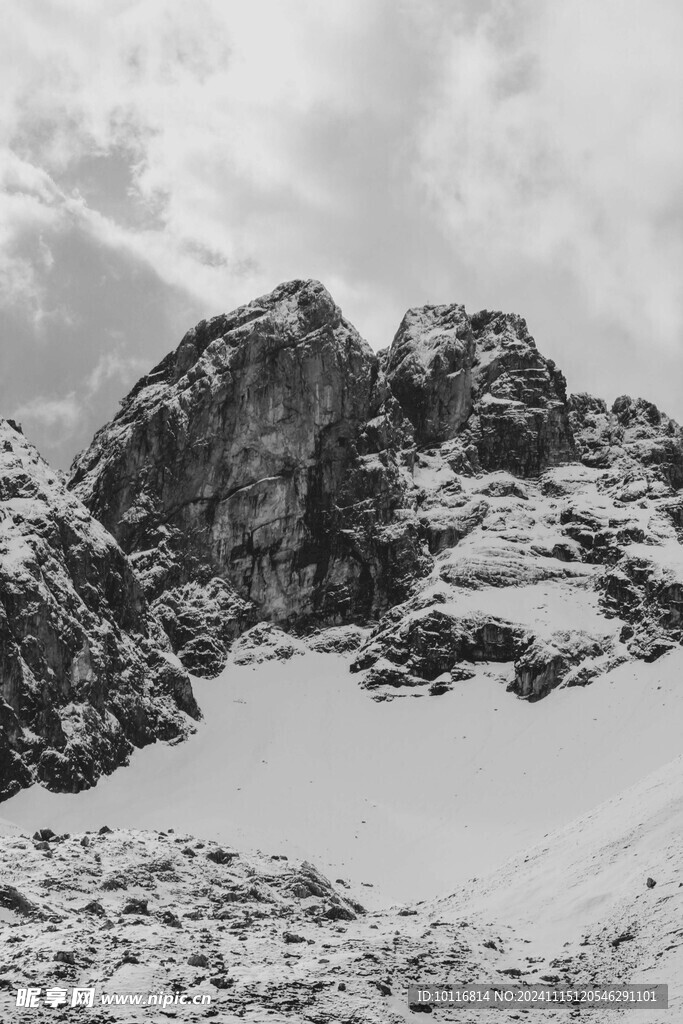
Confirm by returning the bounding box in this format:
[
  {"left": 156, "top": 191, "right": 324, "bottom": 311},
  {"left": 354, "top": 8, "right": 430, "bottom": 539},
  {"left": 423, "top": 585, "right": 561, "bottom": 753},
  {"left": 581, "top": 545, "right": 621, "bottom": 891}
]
[{"left": 3, "top": 649, "right": 683, "bottom": 905}]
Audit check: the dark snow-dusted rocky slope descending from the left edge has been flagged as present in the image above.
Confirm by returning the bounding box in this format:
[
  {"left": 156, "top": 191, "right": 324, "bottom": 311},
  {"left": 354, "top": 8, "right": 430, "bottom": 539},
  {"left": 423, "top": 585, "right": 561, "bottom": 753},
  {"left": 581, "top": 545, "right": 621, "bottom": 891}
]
[{"left": 0, "top": 420, "right": 199, "bottom": 799}]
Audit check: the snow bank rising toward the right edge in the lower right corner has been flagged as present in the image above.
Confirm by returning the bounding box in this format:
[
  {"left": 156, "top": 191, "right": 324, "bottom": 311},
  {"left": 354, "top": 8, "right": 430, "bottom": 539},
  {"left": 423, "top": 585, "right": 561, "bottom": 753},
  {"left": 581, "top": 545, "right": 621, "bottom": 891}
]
[{"left": 431, "top": 757, "right": 683, "bottom": 1022}]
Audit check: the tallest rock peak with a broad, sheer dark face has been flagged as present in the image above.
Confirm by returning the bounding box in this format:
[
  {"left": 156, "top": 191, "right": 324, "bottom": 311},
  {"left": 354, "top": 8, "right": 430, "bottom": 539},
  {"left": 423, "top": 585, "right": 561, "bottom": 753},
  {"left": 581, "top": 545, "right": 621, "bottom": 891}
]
[{"left": 66, "top": 282, "right": 424, "bottom": 674}]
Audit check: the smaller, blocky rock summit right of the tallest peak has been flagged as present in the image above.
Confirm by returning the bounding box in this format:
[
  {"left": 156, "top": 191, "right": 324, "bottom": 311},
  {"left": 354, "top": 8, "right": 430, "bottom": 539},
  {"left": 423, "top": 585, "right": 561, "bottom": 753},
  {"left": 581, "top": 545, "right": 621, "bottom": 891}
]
[{"left": 385, "top": 305, "right": 575, "bottom": 476}]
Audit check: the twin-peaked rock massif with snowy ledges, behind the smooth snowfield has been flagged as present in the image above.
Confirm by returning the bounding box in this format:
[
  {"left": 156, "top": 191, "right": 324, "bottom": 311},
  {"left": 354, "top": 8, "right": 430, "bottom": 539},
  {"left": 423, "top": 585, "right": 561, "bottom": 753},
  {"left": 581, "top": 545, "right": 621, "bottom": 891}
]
[{"left": 70, "top": 282, "right": 683, "bottom": 699}]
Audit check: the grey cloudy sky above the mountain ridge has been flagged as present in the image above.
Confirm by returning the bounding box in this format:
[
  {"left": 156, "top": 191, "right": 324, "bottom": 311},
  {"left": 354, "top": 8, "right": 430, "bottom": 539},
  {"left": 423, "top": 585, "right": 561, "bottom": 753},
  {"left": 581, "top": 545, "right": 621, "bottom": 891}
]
[{"left": 0, "top": 0, "right": 683, "bottom": 467}]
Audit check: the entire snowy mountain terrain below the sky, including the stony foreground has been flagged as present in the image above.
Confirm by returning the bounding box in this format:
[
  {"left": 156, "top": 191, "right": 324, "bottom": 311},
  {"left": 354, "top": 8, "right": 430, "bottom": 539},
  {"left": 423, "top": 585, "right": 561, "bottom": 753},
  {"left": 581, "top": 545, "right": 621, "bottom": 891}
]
[{"left": 0, "top": 282, "right": 683, "bottom": 1022}]
